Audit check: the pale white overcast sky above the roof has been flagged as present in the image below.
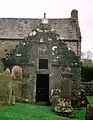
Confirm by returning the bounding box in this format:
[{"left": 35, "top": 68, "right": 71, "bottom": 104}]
[{"left": 0, "top": 0, "right": 93, "bottom": 52}]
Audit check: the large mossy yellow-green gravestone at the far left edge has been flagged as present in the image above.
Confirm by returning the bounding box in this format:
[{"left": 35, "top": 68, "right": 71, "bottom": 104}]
[{"left": 0, "top": 69, "right": 14, "bottom": 105}]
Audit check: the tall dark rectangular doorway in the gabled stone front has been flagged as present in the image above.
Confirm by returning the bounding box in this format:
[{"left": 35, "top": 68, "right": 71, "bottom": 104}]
[{"left": 36, "top": 74, "right": 49, "bottom": 103}]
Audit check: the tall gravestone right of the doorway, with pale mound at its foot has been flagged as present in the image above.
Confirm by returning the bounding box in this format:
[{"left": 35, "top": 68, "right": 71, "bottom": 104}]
[{"left": 54, "top": 72, "right": 73, "bottom": 116}]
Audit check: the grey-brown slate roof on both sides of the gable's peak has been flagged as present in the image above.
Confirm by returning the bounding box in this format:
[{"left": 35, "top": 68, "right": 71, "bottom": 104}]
[{"left": 0, "top": 9, "right": 81, "bottom": 40}]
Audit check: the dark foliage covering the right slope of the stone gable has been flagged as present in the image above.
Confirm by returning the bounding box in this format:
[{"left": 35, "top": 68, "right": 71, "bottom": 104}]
[{"left": 55, "top": 41, "right": 81, "bottom": 70}]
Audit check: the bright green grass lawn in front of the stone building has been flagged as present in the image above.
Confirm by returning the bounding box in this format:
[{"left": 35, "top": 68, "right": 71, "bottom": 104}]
[{"left": 0, "top": 103, "right": 86, "bottom": 120}]
